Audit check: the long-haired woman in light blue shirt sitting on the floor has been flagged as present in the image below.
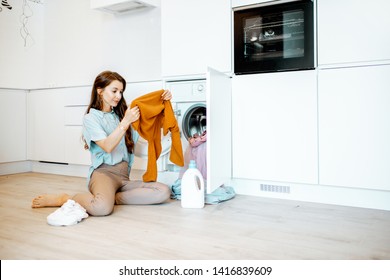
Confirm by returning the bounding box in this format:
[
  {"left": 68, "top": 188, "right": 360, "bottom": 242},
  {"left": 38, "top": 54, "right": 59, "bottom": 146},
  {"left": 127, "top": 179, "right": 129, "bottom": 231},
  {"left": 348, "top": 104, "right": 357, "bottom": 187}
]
[{"left": 32, "top": 71, "right": 172, "bottom": 225}]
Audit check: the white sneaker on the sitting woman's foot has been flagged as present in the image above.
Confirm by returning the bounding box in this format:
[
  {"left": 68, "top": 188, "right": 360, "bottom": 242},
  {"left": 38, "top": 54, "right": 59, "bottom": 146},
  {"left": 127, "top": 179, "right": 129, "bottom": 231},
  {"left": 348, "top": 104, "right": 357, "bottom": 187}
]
[{"left": 47, "top": 199, "right": 88, "bottom": 226}]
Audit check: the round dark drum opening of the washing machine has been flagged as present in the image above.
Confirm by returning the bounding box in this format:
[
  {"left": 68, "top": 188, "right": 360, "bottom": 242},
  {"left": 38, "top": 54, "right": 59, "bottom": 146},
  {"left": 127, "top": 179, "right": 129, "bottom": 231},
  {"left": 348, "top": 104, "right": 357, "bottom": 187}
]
[{"left": 182, "top": 104, "right": 207, "bottom": 140}]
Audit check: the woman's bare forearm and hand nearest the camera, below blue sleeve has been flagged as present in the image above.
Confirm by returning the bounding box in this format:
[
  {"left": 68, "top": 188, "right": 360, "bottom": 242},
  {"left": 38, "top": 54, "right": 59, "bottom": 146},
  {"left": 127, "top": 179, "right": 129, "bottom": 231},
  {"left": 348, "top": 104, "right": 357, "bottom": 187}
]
[{"left": 95, "top": 106, "right": 139, "bottom": 153}]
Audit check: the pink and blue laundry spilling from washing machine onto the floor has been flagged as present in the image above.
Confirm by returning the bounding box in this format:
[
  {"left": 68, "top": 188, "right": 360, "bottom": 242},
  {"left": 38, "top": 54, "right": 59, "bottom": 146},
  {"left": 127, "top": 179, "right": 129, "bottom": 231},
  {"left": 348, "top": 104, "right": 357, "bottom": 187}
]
[{"left": 171, "top": 131, "right": 236, "bottom": 204}]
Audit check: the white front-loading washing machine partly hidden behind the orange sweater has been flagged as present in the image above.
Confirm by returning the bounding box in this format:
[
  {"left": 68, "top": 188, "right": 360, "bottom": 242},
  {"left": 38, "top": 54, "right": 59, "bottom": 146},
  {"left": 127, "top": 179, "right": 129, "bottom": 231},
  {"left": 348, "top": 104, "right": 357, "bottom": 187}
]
[{"left": 165, "top": 80, "right": 207, "bottom": 171}]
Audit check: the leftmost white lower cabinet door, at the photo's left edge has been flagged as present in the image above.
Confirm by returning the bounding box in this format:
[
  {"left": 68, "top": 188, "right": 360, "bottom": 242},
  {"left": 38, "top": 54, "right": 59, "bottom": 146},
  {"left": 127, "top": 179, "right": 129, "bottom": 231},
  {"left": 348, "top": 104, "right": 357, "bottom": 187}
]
[{"left": 0, "top": 89, "right": 27, "bottom": 163}]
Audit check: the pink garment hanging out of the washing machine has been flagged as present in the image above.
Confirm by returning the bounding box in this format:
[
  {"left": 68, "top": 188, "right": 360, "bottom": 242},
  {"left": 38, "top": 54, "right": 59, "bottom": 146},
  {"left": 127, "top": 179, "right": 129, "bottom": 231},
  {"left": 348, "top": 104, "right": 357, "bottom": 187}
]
[{"left": 179, "top": 141, "right": 207, "bottom": 180}]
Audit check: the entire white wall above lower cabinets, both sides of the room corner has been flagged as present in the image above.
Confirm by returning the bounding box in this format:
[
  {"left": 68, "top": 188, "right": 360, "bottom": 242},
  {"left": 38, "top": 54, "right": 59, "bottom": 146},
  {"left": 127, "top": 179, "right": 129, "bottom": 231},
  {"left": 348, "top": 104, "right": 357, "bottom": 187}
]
[{"left": 0, "top": 0, "right": 161, "bottom": 89}]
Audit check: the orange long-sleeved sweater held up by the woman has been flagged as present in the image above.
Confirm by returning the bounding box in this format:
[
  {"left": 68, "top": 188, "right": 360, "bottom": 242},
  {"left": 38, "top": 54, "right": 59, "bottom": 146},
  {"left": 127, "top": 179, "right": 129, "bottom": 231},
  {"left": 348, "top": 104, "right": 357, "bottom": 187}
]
[{"left": 130, "top": 90, "right": 184, "bottom": 182}]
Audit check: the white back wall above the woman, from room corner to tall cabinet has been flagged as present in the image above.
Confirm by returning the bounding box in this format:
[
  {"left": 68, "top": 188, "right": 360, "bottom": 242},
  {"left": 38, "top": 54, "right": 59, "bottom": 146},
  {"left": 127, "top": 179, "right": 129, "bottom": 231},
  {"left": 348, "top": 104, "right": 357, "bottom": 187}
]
[{"left": 40, "top": 0, "right": 161, "bottom": 87}]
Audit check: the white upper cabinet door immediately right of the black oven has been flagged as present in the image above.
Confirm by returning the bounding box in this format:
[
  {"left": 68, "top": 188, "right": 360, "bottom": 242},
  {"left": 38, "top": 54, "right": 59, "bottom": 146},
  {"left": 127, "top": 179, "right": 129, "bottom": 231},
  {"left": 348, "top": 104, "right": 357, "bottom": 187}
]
[{"left": 317, "top": 0, "right": 390, "bottom": 66}]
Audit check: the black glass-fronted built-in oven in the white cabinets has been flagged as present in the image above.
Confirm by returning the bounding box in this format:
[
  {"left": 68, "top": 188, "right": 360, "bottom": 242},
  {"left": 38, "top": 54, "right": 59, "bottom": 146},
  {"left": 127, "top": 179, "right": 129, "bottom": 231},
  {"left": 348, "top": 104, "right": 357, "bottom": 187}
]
[{"left": 234, "top": 0, "right": 315, "bottom": 75}]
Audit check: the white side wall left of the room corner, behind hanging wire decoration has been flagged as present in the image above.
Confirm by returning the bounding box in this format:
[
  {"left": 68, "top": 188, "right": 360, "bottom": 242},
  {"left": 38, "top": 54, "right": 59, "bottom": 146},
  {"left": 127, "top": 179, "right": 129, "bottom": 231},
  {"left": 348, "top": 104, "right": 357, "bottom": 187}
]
[{"left": 0, "top": 1, "right": 44, "bottom": 89}]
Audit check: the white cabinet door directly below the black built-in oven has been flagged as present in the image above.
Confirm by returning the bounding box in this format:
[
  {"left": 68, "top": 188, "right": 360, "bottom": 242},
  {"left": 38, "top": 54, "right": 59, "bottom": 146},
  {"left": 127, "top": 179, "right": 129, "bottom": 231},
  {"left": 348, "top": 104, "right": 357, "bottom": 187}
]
[{"left": 232, "top": 71, "right": 318, "bottom": 184}]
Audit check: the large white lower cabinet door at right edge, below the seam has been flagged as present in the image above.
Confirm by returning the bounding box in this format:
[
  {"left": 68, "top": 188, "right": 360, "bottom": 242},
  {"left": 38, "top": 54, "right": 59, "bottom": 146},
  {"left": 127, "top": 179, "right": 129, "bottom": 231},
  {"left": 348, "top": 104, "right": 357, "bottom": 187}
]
[{"left": 319, "top": 65, "right": 390, "bottom": 190}]
